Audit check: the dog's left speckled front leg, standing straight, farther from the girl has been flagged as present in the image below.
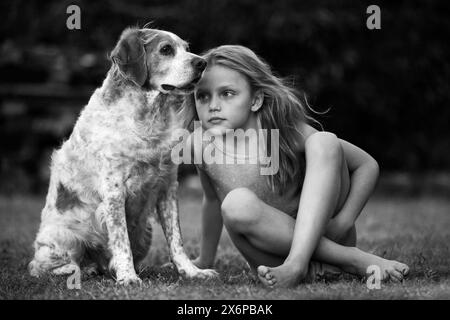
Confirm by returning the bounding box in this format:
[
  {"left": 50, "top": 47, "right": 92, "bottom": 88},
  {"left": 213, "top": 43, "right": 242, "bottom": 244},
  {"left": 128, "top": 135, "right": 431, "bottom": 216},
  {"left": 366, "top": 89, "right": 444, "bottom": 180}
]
[{"left": 99, "top": 175, "right": 141, "bottom": 285}]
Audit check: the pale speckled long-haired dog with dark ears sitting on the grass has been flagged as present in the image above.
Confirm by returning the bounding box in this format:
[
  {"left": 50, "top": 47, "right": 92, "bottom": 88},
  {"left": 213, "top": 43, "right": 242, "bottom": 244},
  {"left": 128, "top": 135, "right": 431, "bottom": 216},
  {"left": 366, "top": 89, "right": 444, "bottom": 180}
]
[{"left": 29, "top": 28, "right": 217, "bottom": 285}]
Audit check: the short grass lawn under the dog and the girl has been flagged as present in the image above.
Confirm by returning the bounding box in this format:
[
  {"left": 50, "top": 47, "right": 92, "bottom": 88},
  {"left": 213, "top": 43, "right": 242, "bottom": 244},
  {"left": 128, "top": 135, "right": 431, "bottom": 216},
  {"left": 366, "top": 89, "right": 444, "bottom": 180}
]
[{"left": 0, "top": 180, "right": 450, "bottom": 300}]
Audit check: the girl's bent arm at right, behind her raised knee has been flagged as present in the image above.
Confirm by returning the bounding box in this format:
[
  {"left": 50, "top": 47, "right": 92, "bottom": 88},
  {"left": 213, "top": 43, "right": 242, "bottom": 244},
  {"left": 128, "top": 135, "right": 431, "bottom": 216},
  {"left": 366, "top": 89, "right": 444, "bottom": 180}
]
[{"left": 327, "top": 139, "right": 379, "bottom": 241}]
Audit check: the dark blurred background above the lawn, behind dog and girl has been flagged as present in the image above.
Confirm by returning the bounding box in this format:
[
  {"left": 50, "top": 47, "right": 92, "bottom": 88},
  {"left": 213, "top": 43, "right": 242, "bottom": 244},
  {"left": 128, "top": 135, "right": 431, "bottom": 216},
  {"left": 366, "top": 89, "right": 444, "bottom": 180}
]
[{"left": 0, "top": 0, "right": 450, "bottom": 195}]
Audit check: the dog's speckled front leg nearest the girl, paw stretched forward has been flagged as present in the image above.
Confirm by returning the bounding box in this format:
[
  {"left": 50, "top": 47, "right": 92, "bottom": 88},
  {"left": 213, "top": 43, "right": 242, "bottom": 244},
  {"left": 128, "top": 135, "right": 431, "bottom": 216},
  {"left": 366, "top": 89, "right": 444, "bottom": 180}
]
[{"left": 157, "top": 181, "right": 217, "bottom": 279}]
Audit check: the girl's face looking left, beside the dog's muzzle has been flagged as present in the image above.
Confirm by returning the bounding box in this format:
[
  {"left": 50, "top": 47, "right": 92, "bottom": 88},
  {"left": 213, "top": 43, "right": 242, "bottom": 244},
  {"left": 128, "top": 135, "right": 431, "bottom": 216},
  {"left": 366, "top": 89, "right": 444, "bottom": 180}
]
[{"left": 194, "top": 65, "right": 256, "bottom": 135}]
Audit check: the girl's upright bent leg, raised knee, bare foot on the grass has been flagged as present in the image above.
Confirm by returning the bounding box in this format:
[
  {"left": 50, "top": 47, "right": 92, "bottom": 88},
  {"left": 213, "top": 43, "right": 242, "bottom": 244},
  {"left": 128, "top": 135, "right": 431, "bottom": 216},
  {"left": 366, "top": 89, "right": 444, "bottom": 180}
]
[{"left": 260, "top": 133, "right": 350, "bottom": 286}]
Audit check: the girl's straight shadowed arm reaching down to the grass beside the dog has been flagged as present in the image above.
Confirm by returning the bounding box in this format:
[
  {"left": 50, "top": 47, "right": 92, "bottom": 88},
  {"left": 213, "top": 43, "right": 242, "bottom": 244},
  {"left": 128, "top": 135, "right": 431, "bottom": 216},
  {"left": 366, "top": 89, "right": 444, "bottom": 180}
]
[{"left": 194, "top": 168, "right": 223, "bottom": 269}]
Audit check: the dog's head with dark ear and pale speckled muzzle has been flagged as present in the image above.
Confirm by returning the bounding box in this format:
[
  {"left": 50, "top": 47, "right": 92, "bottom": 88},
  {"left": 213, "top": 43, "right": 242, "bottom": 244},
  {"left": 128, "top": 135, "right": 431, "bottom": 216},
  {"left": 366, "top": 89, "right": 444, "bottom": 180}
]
[{"left": 111, "top": 28, "right": 206, "bottom": 93}]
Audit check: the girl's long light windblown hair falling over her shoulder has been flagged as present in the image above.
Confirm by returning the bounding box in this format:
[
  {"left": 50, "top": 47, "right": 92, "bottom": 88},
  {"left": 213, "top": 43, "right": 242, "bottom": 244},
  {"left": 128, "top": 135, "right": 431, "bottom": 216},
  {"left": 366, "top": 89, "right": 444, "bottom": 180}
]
[{"left": 182, "top": 45, "right": 321, "bottom": 193}]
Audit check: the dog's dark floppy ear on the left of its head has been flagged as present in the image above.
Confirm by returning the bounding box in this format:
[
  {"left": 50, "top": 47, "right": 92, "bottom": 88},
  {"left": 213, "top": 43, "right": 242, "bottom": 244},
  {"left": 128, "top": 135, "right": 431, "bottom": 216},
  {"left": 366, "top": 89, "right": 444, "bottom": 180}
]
[{"left": 110, "top": 29, "right": 148, "bottom": 87}]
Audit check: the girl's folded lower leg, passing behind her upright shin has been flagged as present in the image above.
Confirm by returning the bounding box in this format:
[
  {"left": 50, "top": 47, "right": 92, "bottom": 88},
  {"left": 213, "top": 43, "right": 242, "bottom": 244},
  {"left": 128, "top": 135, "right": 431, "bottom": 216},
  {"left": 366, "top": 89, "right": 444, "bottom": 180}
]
[{"left": 222, "top": 188, "right": 408, "bottom": 285}]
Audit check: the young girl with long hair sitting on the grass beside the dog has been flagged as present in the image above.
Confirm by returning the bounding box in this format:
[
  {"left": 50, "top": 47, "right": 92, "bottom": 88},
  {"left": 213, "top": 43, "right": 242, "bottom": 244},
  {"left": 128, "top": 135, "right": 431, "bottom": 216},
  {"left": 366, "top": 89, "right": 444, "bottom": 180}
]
[{"left": 182, "top": 45, "right": 408, "bottom": 286}]
